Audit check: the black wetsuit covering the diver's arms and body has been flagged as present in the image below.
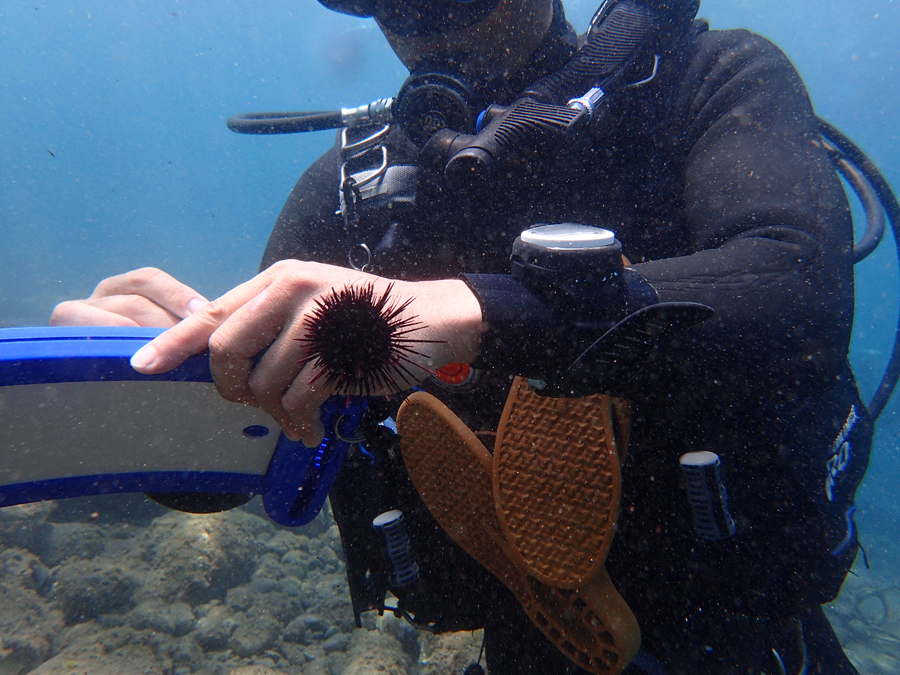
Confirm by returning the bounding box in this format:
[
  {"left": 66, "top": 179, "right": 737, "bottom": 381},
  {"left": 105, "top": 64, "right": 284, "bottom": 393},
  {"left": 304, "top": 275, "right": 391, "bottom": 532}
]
[{"left": 263, "top": 23, "right": 871, "bottom": 674}]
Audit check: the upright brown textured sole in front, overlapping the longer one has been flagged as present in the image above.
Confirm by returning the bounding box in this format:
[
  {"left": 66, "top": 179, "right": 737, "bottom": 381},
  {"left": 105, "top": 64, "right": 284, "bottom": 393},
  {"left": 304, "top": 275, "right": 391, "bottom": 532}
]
[{"left": 493, "top": 378, "right": 621, "bottom": 588}]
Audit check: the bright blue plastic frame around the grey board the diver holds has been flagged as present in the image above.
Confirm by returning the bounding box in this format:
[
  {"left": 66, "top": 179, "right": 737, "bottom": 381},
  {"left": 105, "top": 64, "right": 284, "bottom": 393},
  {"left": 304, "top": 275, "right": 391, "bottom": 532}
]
[{"left": 0, "top": 326, "right": 364, "bottom": 526}]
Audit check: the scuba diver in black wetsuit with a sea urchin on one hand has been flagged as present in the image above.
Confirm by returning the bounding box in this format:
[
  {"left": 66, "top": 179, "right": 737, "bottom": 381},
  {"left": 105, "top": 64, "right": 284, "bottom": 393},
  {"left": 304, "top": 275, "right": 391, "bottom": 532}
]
[{"left": 52, "top": 0, "right": 896, "bottom": 675}]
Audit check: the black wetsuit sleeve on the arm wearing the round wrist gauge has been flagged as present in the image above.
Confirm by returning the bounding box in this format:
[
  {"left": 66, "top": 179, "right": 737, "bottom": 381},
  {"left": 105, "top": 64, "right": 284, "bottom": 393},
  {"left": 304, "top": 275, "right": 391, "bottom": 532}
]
[{"left": 467, "top": 31, "right": 853, "bottom": 397}]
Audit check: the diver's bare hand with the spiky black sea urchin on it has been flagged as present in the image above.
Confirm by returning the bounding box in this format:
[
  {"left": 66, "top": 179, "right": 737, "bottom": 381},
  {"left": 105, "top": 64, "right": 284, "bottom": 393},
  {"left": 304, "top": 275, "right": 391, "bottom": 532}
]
[{"left": 131, "top": 260, "right": 481, "bottom": 446}]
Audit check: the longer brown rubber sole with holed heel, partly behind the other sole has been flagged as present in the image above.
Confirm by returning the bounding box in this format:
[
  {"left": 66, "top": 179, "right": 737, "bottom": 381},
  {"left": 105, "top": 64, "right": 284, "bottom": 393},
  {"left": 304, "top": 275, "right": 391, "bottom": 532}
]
[{"left": 397, "top": 392, "right": 640, "bottom": 675}]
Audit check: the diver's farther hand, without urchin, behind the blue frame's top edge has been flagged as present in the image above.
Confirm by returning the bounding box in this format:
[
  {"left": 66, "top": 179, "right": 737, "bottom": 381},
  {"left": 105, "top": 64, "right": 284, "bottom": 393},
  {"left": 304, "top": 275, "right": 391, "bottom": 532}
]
[{"left": 50, "top": 267, "right": 209, "bottom": 328}]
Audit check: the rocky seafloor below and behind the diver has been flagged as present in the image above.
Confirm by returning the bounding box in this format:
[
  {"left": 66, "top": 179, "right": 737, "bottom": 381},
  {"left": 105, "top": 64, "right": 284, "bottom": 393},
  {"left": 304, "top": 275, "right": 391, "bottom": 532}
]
[{"left": 0, "top": 496, "right": 900, "bottom": 675}]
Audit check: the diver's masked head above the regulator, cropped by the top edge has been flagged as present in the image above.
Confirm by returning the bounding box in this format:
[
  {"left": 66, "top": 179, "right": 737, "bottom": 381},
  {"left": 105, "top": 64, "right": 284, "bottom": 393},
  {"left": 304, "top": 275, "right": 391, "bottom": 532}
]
[{"left": 319, "top": 0, "right": 554, "bottom": 82}]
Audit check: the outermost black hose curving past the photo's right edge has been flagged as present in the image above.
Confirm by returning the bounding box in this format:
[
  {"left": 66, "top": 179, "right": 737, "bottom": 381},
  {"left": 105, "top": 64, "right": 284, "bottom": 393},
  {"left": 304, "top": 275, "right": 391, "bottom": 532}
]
[{"left": 819, "top": 118, "right": 900, "bottom": 421}]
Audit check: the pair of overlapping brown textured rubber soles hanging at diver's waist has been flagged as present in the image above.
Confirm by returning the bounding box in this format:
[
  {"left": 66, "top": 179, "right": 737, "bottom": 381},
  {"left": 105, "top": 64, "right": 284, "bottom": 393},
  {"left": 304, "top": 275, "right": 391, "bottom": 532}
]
[{"left": 397, "top": 379, "right": 640, "bottom": 675}]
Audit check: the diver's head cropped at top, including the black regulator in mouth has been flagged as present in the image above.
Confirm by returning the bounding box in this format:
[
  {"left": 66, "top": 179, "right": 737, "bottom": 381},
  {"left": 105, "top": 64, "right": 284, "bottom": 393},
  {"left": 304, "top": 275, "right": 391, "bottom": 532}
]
[{"left": 319, "top": 0, "right": 577, "bottom": 146}]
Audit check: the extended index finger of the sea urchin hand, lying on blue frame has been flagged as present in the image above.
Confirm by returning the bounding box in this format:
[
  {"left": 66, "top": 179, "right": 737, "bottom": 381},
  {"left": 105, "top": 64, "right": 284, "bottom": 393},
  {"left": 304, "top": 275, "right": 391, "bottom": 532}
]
[{"left": 131, "top": 274, "right": 270, "bottom": 375}]
